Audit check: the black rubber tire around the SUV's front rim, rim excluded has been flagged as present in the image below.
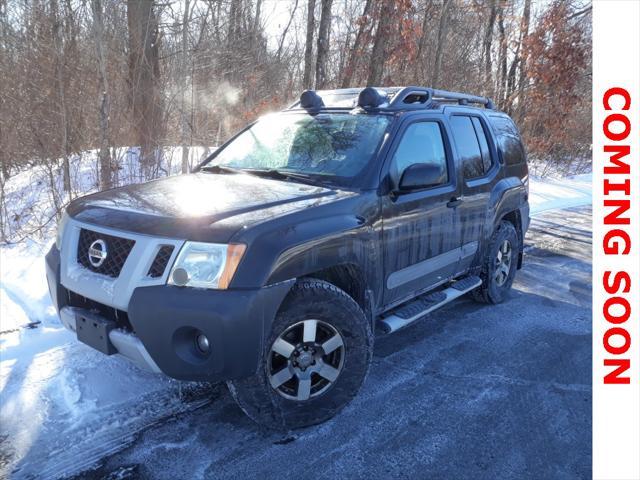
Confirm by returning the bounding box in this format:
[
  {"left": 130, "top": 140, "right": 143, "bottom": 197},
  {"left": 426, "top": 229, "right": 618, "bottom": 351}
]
[{"left": 227, "top": 278, "right": 374, "bottom": 430}]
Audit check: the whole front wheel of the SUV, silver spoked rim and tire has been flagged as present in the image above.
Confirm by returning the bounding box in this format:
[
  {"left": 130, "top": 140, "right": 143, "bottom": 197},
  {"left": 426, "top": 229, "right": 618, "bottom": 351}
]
[{"left": 227, "top": 279, "right": 373, "bottom": 429}]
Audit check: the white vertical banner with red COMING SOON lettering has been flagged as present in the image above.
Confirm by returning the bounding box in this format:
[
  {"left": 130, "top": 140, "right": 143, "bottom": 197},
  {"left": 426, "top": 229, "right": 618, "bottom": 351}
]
[{"left": 593, "top": 0, "right": 640, "bottom": 480}]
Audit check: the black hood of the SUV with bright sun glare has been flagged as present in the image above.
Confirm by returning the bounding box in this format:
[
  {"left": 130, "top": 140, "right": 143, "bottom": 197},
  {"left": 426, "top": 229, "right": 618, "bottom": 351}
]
[{"left": 67, "top": 173, "right": 346, "bottom": 242}]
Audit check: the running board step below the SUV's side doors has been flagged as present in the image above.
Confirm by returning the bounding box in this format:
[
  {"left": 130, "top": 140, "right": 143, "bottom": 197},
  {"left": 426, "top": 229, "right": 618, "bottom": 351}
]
[{"left": 378, "top": 276, "right": 482, "bottom": 333}]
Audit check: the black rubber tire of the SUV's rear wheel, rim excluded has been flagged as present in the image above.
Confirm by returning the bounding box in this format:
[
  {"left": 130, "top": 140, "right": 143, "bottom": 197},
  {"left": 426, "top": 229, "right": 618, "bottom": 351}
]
[{"left": 473, "top": 221, "right": 520, "bottom": 304}]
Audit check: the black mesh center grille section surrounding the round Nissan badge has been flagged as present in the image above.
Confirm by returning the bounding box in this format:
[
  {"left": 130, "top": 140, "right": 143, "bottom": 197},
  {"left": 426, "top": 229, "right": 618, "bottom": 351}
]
[{"left": 78, "top": 228, "right": 136, "bottom": 278}]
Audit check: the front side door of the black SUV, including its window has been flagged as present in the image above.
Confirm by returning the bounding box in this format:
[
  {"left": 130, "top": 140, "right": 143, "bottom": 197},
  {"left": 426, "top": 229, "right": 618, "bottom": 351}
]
[{"left": 382, "top": 115, "right": 461, "bottom": 306}]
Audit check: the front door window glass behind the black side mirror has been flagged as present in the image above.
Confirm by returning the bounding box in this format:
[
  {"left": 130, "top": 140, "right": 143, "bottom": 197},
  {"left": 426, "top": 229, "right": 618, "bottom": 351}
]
[{"left": 391, "top": 122, "right": 449, "bottom": 184}]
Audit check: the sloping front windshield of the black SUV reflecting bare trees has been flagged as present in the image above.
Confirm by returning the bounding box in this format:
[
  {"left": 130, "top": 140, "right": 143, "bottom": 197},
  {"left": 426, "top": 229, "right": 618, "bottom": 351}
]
[{"left": 212, "top": 113, "right": 390, "bottom": 185}]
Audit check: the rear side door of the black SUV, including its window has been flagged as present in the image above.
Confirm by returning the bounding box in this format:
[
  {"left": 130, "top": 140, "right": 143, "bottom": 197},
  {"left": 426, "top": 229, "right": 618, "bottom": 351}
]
[{"left": 449, "top": 110, "right": 501, "bottom": 275}]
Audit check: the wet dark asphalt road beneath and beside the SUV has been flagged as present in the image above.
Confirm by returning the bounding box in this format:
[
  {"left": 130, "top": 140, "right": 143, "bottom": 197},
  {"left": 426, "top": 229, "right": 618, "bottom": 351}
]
[{"left": 74, "top": 207, "right": 591, "bottom": 480}]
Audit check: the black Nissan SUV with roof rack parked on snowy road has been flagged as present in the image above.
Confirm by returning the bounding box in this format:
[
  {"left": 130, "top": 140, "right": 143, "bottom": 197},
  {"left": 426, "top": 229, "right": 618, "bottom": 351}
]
[{"left": 46, "top": 87, "right": 529, "bottom": 428}]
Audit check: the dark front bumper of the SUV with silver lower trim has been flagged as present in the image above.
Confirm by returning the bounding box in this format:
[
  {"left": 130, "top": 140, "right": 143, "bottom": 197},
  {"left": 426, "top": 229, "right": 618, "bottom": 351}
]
[{"left": 46, "top": 245, "right": 293, "bottom": 381}]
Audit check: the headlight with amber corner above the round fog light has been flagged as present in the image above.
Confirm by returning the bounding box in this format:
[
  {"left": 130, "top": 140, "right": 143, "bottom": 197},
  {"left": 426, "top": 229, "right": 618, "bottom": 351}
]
[{"left": 168, "top": 242, "right": 246, "bottom": 290}]
